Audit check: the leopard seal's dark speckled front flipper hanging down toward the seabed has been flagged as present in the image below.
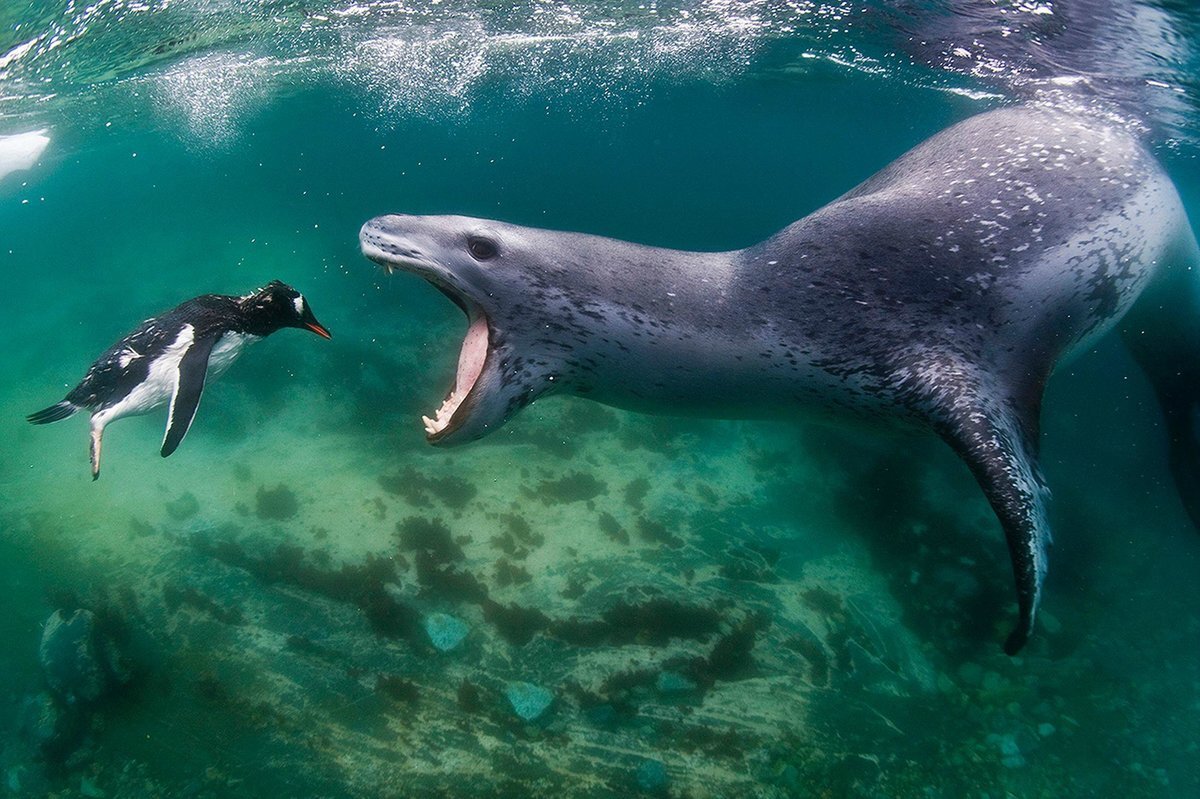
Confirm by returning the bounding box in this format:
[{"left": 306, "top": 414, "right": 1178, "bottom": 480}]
[{"left": 932, "top": 376, "right": 1050, "bottom": 655}]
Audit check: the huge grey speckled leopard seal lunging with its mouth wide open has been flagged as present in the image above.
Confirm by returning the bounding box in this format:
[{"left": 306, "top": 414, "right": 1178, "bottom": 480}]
[{"left": 360, "top": 107, "right": 1200, "bottom": 654}]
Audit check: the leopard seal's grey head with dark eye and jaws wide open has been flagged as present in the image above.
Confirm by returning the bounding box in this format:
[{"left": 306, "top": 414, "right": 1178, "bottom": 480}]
[{"left": 359, "top": 215, "right": 578, "bottom": 445}]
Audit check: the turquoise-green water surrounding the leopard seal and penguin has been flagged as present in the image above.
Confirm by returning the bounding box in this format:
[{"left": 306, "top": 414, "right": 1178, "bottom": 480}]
[{"left": 0, "top": 1, "right": 1200, "bottom": 797}]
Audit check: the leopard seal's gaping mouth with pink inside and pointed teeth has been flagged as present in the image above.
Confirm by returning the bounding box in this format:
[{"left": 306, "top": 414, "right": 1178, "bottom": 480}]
[{"left": 362, "top": 234, "right": 492, "bottom": 444}]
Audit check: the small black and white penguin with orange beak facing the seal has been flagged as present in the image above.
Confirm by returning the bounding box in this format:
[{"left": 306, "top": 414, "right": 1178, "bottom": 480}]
[{"left": 26, "top": 281, "right": 330, "bottom": 480}]
